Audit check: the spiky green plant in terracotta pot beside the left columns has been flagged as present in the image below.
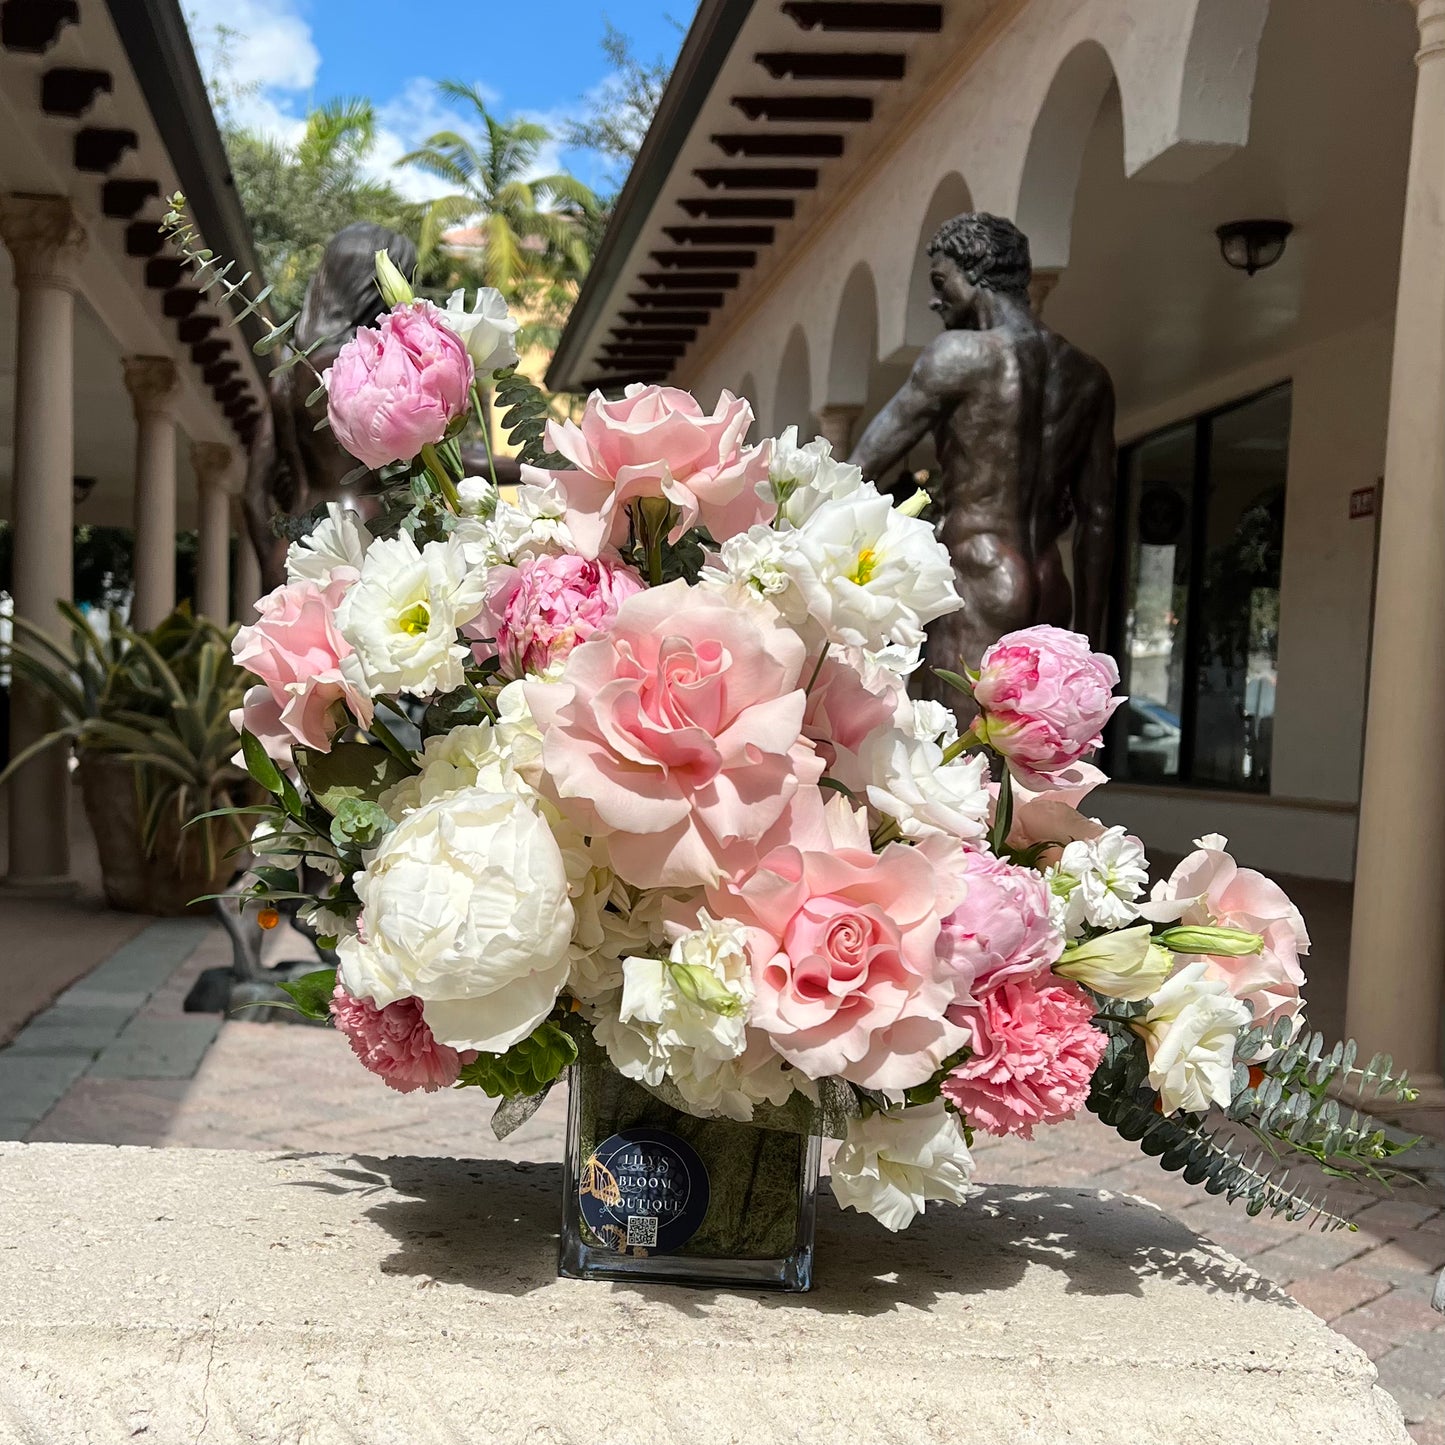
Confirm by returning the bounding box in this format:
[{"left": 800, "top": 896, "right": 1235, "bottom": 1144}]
[{"left": 0, "top": 603, "right": 253, "bottom": 915}]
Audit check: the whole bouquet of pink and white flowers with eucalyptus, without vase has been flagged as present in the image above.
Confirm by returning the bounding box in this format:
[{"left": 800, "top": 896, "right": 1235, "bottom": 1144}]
[{"left": 174, "top": 222, "right": 1409, "bottom": 1230}]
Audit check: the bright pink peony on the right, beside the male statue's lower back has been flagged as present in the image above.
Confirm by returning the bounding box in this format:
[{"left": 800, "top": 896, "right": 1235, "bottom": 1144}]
[{"left": 974, "top": 626, "right": 1124, "bottom": 788}]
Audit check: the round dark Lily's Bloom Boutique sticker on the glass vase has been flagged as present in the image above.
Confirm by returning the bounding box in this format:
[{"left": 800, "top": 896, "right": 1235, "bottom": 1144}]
[{"left": 577, "top": 1129, "right": 708, "bottom": 1254}]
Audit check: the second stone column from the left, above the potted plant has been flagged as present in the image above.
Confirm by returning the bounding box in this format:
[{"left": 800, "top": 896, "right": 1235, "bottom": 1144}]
[{"left": 124, "top": 357, "right": 179, "bottom": 630}]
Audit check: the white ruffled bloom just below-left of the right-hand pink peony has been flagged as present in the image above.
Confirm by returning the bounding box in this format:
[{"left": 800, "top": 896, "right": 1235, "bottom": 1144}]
[{"left": 858, "top": 728, "right": 991, "bottom": 842}]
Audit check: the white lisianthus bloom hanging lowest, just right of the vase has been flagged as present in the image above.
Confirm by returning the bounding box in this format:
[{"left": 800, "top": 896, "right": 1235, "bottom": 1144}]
[{"left": 832, "top": 1100, "right": 974, "bottom": 1233}]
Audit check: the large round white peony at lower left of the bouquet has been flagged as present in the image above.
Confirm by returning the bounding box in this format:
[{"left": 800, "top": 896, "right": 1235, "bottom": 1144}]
[{"left": 337, "top": 788, "right": 572, "bottom": 1053}]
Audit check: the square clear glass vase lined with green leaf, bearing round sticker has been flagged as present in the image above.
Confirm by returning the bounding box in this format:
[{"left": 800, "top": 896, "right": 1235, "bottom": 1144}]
[{"left": 558, "top": 1045, "right": 822, "bottom": 1292}]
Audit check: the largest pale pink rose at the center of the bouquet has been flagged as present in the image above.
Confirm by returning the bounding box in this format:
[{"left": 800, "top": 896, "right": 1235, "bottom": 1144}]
[{"left": 526, "top": 582, "right": 822, "bottom": 889}]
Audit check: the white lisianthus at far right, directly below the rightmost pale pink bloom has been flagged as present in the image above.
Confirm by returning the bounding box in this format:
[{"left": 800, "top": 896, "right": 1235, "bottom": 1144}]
[{"left": 1131, "top": 962, "right": 1250, "bottom": 1114}]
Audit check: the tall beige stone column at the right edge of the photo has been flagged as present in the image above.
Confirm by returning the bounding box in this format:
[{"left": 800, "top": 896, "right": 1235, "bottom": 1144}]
[{"left": 1345, "top": 0, "right": 1445, "bottom": 1087}]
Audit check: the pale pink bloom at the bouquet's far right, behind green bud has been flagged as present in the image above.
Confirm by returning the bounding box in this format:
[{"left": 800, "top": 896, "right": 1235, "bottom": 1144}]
[{"left": 1142, "top": 834, "right": 1309, "bottom": 1027}]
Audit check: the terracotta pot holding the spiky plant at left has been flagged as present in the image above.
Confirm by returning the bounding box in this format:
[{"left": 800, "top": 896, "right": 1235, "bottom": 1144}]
[{"left": 77, "top": 753, "right": 246, "bottom": 918}]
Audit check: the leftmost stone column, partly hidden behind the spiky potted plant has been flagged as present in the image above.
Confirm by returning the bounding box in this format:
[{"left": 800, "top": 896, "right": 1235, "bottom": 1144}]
[{"left": 0, "top": 195, "right": 85, "bottom": 892}]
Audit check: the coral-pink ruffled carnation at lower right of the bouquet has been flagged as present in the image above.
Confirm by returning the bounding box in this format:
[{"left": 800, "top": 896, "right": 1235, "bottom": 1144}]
[{"left": 944, "top": 980, "right": 1107, "bottom": 1139}]
